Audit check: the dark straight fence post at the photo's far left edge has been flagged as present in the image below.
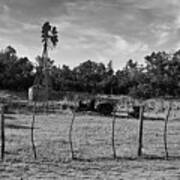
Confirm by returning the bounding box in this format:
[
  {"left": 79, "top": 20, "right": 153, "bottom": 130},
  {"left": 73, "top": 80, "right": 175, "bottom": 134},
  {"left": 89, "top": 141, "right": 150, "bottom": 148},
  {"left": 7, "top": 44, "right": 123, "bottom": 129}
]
[{"left": 1, "top": 106, "right": 5, "bottom": 161}]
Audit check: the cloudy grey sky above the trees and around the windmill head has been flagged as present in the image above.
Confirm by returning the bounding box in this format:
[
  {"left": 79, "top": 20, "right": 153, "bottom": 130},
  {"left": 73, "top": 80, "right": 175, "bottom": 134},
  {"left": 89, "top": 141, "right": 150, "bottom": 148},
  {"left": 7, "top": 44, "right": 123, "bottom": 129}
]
[{"left": 0, "top": 0, "right": 180, "bottom": 69}]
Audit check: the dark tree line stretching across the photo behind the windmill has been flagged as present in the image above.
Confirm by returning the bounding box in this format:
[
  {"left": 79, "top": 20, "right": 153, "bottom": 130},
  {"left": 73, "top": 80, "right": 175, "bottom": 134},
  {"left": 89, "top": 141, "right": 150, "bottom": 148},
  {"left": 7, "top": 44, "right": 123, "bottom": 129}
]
[{"left": 0, "top": 46, "right": 180, "bottom": 98}]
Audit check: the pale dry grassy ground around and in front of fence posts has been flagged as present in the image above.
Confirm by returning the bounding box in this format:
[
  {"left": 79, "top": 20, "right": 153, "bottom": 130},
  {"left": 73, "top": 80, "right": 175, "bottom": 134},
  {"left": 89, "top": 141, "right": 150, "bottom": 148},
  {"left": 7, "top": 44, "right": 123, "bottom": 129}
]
[{"left": 0, "top": 112, "right": 180, "bottom": 180}]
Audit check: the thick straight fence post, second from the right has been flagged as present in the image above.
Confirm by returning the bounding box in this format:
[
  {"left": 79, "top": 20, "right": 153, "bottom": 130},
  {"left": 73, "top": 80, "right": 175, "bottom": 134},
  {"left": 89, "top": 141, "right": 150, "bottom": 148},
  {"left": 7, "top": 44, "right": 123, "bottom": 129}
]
[{"left": 138, "top": 105, "right": 144, "bottom": 156}]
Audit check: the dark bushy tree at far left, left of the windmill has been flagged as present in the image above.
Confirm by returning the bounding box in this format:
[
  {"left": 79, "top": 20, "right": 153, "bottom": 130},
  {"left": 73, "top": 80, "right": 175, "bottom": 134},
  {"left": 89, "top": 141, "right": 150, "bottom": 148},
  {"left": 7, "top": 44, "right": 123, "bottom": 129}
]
[{"left": 0, "top": 46, "right": 34, "bottom": 90}]
